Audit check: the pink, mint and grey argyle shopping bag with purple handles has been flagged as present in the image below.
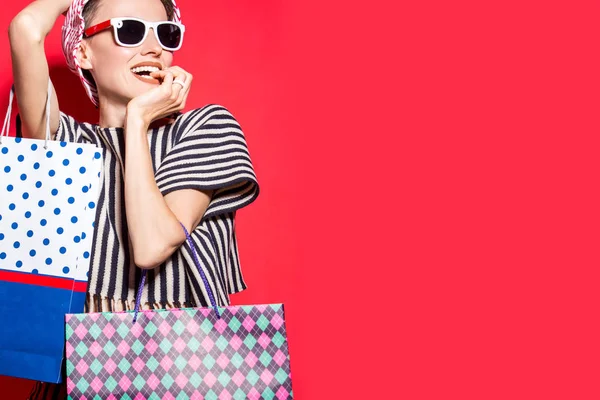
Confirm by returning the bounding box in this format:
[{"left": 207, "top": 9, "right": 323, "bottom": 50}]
[{"left": 66, "top": 228, "right": 293, "bottom": 400}]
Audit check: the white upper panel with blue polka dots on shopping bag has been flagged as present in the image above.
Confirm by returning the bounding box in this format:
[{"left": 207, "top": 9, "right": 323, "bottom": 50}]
[{"left": 0, "top": 137, "right": 102, "bottom": 281}]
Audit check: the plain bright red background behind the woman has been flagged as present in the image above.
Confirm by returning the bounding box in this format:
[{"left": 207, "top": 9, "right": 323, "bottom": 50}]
[{"left": 0, "top": 0, "right": 600, "bottom": 400}]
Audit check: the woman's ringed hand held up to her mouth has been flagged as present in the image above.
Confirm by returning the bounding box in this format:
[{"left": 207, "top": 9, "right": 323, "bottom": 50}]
[{"left": 127, "top": 67, "right": 192, "bottom": 126}]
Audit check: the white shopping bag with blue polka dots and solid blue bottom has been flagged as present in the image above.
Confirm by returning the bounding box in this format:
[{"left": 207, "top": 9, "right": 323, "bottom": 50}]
[{"left": 0, "top": 85, "right": 102, "bottom": 383}]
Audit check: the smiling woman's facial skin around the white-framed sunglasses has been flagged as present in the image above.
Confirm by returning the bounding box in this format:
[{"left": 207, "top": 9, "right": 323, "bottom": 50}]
[{"left": 82, "top": 0, "right": 173, "bottom": 105}]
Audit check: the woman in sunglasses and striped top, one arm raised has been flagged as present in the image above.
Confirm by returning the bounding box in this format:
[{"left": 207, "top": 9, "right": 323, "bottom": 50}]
[{"left": 9, "top": 0, "right": 258, "bottom": 399}]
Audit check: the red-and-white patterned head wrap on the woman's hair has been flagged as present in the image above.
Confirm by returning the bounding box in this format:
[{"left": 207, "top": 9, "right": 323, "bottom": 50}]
[{"left": 62, "top": 0, "right": 181, "bottom": 107}]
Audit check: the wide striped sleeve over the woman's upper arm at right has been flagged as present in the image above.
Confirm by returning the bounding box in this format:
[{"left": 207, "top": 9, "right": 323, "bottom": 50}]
[{"left": 155, "top": 105, "right": 259, "bottom": 218}]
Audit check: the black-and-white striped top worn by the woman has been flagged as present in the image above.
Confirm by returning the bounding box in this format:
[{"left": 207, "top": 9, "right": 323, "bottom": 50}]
[{"left": 56, "top": 105, "right": 259, "bottom": 312}]
